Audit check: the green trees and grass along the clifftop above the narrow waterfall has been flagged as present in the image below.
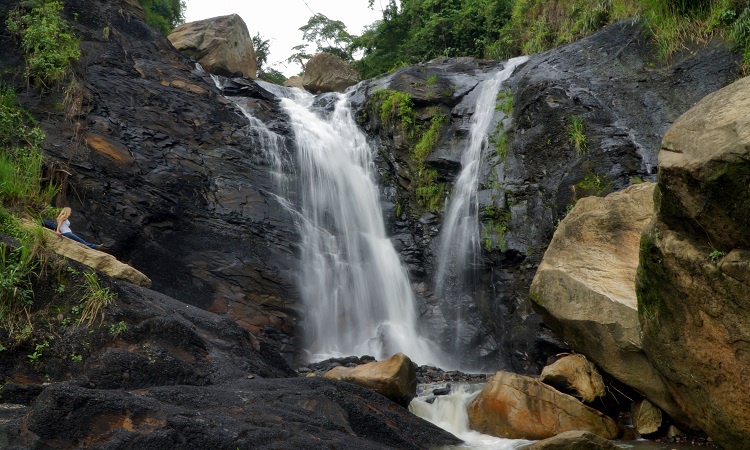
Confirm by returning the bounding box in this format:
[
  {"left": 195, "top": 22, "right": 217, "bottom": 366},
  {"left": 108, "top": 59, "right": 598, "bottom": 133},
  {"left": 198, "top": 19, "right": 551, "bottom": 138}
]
[{"left": 351, "top": 0, "right": 750, "bottom": 78}]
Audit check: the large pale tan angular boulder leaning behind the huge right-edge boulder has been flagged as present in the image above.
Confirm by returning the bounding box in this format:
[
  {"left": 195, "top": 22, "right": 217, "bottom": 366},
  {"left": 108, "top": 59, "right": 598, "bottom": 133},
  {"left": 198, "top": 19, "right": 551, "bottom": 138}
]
[{"left": 531, "top": 183, "right": 689, "bottom": 423}]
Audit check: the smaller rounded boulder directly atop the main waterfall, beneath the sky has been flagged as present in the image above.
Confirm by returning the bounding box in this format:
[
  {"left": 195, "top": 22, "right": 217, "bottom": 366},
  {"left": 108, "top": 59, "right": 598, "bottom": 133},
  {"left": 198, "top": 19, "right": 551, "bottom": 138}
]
[{"left": 302, "top": 52, "right": 359, "bottom": 94}]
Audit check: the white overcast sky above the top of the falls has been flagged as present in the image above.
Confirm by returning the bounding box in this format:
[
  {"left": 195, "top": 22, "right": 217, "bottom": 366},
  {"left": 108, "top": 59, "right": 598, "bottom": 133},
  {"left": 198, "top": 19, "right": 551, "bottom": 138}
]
[{"left": 185, "top": 0, "right": 385, "bottom": 77}]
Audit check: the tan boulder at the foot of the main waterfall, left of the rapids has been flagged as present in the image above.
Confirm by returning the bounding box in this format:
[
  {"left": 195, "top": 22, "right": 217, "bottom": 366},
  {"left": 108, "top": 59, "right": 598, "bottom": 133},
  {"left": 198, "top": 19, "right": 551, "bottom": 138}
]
[{"left": 323, "top": 353, "right": 417, "bottom": 406}]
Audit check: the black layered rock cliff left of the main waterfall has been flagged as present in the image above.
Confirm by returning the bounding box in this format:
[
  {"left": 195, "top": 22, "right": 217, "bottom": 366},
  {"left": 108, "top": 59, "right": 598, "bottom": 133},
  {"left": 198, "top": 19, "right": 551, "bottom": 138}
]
[{"left": 0, "top": 0, "right": 298, "bottom": 359}]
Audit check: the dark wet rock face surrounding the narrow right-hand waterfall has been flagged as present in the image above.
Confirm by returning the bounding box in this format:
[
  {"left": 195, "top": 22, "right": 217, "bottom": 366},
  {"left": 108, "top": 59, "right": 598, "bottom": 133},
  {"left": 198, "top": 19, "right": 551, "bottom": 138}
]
[{"left": 352, "top": 21, "right": 738, "bottom": 373}]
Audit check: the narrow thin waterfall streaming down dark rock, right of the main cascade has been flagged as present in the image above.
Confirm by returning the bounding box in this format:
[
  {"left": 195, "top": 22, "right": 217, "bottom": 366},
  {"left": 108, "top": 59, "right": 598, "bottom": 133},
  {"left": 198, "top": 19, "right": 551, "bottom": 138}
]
[{"left": 435, "top": 56, "right": 528, "bottom": 345}]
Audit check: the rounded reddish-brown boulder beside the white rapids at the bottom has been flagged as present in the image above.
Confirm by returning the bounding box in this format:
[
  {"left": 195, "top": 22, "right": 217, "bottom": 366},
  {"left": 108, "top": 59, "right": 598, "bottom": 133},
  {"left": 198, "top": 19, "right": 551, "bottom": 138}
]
[{"left": 468, "top": 372, "right": 620, "bottom": 439}]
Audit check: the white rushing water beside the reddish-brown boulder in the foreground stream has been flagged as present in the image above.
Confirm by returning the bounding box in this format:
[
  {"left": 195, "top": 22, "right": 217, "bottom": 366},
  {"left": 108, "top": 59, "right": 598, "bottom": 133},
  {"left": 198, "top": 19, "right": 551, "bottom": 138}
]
[{"left": 409, "top": 384, "right": 533, "bottom": 450}]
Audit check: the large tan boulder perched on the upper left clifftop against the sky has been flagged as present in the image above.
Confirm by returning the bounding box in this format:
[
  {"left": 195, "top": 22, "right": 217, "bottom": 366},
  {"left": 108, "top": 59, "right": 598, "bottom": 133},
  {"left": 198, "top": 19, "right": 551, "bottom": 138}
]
[{"left": 167, "top": 14, "right": 257, "bottom": 78}]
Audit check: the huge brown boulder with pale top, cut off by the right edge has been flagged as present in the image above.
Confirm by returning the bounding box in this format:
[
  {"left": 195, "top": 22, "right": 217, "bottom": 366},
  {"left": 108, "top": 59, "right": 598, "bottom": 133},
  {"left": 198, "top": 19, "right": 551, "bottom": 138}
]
[{"left": 637, "top": 78, "right": 750, "bottom": 449}]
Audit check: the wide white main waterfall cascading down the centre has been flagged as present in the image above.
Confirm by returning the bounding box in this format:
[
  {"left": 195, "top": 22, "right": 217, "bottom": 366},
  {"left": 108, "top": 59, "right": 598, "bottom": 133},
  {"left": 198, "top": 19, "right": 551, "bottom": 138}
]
[{"left": 276, "top": 90, "right": 442, "bottom": 365}]
